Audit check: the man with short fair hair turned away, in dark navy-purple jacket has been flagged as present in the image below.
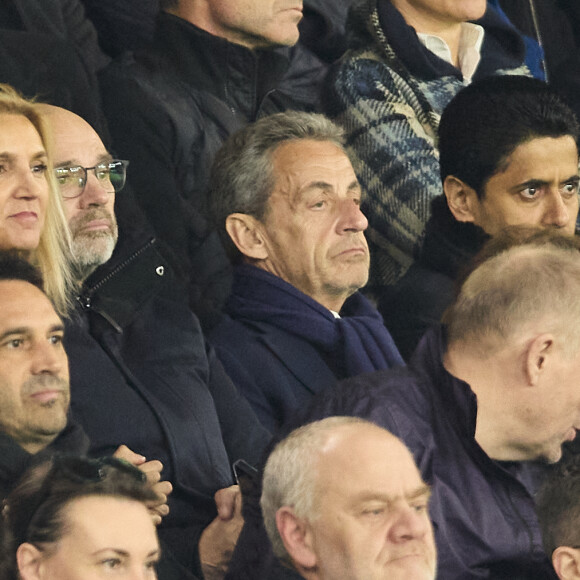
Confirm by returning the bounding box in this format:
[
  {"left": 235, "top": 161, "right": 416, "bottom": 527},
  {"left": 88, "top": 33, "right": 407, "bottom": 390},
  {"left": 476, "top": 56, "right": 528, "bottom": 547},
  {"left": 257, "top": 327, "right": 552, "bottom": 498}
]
[{"left": 308, "top": 233, "right": 580, "bottom": 580}]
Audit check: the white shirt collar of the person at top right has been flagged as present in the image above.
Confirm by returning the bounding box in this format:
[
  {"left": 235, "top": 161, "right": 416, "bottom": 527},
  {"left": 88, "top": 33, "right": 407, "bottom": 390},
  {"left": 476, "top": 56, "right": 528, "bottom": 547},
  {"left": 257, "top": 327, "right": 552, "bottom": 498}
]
[{"left": 417, "top": 22, "right": 485, "bottom": 84}]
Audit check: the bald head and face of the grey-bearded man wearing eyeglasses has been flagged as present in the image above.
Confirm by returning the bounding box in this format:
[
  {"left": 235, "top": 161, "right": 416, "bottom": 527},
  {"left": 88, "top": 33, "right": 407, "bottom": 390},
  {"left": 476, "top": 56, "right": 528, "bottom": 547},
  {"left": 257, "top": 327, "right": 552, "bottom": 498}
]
[{"left": 41, "top": 105, "right": 118, "bottom": 280}]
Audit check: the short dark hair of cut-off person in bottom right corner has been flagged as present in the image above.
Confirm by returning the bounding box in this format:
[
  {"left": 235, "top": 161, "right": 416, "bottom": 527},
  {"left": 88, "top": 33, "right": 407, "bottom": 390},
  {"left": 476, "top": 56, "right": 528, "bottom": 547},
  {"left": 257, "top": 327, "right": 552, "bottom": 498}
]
[{"left": 536, "top": 453, "right": 580, "bottom": 556}]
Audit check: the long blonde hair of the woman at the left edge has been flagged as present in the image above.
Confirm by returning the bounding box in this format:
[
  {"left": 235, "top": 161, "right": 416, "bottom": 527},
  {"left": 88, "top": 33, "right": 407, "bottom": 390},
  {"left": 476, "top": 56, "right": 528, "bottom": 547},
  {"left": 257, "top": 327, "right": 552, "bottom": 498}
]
[{"left": 0, "top": 83, "right": 73, "bottom": 315}]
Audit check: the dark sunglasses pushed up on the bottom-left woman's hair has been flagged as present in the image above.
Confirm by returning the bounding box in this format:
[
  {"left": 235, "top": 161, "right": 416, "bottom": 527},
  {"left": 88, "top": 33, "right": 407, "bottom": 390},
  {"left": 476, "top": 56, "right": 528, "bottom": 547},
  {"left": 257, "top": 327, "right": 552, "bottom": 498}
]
[{"left": 4, "top": 455, "right": 147, "bottom": 544}]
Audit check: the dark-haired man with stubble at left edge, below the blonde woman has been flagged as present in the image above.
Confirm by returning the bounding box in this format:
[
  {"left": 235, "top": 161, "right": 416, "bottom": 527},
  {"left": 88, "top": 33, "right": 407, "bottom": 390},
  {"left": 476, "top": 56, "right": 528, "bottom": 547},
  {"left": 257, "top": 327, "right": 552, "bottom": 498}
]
[{"left": 0, "top": 252, "right": 88, "bottom": 497}]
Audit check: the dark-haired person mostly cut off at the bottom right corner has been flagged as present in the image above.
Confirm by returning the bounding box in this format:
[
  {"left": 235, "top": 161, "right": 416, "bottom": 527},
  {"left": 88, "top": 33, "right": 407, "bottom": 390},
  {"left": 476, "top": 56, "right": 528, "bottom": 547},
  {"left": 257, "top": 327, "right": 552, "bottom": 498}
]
[{"left": 537, "top": 454, "right": 580, "bottom": 580}]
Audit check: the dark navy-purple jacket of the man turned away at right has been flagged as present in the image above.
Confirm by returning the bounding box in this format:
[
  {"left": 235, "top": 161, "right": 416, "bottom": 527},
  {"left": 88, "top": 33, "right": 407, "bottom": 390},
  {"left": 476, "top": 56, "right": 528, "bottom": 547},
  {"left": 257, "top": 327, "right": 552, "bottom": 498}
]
[{"left": 308, "top": 329, "right": 556, "bottom": 580}]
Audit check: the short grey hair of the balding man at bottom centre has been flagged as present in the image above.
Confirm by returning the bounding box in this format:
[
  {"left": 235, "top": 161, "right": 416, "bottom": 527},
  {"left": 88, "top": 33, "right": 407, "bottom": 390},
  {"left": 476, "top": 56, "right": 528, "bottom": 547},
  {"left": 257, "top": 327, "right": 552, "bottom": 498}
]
[{"left": 260, "top": 417, "right": 376, "bottom": 562}]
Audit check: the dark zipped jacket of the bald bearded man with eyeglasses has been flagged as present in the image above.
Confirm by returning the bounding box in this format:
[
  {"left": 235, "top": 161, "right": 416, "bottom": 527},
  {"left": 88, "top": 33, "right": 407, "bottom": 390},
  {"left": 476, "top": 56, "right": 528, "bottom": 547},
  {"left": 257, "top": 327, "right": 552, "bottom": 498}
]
[{"left": 65, "top": 240, "right": 269, "bottom": 571}]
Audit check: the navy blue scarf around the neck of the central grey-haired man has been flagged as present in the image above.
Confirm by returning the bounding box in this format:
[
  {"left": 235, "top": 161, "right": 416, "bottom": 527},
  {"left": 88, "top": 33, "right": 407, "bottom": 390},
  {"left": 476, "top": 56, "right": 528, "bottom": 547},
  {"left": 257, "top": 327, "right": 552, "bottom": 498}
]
[{"left": 226, "top": 265, "right": 404, "bottom": 377}]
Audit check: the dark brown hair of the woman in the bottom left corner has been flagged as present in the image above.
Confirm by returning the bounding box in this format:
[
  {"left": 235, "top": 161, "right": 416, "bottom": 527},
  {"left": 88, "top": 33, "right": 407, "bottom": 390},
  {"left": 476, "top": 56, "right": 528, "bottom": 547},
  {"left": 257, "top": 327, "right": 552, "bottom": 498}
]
[{"left": 0, "top": 454, "right": 157, "bottom": 580}]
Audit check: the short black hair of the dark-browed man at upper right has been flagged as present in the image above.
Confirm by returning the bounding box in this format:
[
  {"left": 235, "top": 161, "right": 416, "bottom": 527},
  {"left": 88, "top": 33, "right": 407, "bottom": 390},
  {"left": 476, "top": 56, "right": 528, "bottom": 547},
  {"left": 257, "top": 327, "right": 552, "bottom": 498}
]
[{"left": 439, "top": 75, "right": 580, "bottom": 199}]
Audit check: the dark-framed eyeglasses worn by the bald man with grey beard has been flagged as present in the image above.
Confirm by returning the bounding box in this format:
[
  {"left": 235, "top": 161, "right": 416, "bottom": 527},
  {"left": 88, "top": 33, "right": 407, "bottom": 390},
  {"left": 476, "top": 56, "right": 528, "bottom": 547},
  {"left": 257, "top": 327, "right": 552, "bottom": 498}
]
[{"left": 54, "top": 159, "right": 129, "bottom": 199}]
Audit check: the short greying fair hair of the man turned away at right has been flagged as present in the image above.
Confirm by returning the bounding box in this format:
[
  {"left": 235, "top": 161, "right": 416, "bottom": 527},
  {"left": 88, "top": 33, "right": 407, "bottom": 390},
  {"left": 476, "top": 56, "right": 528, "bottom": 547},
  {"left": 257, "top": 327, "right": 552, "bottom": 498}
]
[{"left": 444, "top": 241, "right": 580, "bottom": 356}]
